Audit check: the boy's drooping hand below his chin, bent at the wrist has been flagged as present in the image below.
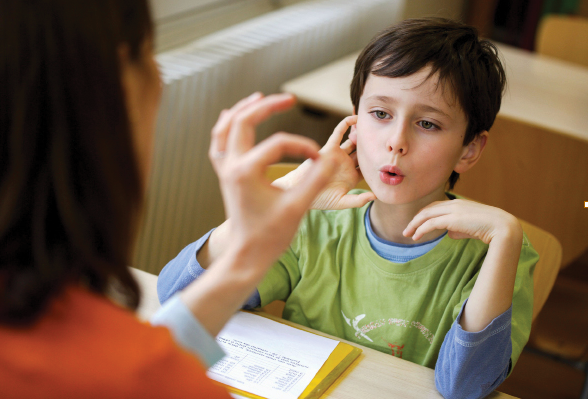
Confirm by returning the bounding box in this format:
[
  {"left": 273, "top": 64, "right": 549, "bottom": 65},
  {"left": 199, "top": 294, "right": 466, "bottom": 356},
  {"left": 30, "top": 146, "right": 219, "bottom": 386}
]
[{"left": 402, "top": 199, "right": 523, "bottom": 245}]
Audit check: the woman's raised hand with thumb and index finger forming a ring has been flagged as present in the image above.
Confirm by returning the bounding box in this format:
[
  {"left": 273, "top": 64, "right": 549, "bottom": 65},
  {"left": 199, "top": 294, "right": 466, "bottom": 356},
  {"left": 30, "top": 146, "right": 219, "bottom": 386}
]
[{"left": 209, "top": 93, "right": 334, "bottom": 267}]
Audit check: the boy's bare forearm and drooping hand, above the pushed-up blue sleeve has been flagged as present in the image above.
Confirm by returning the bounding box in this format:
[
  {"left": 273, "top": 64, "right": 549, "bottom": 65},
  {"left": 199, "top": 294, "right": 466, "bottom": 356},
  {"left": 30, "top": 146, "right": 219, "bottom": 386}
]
[{"left": 403, "top": 199, "right": 523, "bottom": 332}]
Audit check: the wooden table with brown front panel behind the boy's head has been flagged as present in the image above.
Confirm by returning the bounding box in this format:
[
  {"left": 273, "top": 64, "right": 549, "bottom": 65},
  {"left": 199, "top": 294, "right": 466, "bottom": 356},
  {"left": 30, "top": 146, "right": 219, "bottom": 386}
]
[{"left": 282, "top": 45, "right": 588, "bottom": 265}]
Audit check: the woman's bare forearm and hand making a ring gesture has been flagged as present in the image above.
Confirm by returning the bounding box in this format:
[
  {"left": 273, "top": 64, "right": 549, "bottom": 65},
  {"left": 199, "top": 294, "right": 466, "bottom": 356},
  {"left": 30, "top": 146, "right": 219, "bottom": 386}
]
[{"left": 180, "top": 94, "right": 334, "bottom": 336}]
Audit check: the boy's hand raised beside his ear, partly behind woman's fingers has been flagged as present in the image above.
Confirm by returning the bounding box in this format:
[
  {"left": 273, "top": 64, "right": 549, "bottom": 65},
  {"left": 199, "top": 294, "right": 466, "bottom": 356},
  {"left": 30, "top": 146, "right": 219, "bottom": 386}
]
[{"left": 272, "top": 115, "right": 376, "bottom": 209}]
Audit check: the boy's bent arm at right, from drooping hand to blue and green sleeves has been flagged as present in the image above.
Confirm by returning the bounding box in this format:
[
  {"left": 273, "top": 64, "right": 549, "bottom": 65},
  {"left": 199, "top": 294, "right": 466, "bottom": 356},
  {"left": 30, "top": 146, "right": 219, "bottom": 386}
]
[{"left": 405, "top": 200, "right": 538, "bottom": 398}]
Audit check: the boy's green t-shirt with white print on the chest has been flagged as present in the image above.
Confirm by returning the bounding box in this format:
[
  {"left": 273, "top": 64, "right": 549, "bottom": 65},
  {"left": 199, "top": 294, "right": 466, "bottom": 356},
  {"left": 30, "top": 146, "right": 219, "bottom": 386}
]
[{"left": 258, "top": 204, "right": 539, "bottom": 368}]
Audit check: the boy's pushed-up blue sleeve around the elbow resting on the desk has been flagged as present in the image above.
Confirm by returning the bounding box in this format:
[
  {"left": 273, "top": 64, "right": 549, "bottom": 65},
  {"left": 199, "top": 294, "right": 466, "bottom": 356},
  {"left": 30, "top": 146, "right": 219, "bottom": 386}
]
[{"left": 435, "top": 300, "right": 512, "bottom": 399}]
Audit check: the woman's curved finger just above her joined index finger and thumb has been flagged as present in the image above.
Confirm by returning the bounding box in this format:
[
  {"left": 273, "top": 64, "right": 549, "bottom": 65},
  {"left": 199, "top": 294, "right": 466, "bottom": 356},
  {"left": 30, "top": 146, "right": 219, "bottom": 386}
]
[{"left": 227, "top": 94, "right": 295, "bottom": 155}]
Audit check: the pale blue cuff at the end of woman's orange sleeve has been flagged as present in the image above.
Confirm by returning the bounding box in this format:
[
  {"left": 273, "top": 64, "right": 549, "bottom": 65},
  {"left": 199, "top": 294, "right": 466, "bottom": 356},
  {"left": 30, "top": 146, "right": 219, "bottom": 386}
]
[{"left": 150, "top": 295, "right": 225, "bottom": 368}]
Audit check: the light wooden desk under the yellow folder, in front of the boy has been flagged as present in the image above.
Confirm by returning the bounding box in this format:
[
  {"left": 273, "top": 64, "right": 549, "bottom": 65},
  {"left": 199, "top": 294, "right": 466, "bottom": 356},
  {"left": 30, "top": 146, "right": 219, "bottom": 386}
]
[{"left": 131, "top": 269, "right": 513, "bottom": 399}]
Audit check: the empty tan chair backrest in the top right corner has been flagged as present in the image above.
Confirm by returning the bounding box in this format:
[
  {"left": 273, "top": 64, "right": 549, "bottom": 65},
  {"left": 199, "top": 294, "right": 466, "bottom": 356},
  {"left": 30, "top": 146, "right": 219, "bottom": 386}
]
[{"left": 536, "top": 15, "right": 588, "bottom": 66}]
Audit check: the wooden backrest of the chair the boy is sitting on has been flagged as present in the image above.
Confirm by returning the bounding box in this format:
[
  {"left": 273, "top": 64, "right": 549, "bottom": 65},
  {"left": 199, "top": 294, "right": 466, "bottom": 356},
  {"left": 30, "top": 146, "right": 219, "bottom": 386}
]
[{"left": 264, "top": 163, "right": 562, "bottom": 321}]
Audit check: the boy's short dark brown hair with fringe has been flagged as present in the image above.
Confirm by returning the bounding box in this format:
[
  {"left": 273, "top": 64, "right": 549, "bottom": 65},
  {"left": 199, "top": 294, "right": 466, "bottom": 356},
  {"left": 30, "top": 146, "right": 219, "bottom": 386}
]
[{"left": 351, "top": 18, "right": 506, "bottom": 189}]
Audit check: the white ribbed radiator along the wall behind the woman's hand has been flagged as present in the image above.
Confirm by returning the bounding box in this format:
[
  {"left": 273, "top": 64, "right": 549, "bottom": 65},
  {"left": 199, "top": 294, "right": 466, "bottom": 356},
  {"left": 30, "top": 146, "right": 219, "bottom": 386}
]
[{"left": 133, "top": 0, "right": 404, "bottom": 274}]
